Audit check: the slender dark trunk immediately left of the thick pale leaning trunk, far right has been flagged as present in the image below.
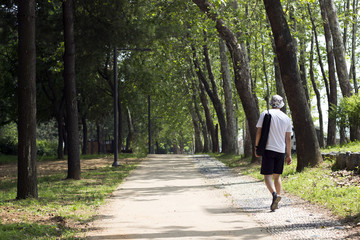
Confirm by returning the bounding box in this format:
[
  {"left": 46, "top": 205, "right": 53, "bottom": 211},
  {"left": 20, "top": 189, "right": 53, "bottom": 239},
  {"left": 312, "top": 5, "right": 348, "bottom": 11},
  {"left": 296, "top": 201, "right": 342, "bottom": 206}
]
[{"left": 320, "top": 0, "right": 337, "bottom": 146}]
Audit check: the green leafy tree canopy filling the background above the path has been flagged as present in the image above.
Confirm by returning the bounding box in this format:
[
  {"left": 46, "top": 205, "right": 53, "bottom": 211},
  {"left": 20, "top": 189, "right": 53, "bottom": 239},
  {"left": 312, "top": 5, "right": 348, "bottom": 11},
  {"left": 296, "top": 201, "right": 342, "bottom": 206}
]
[{"left": 0, "top": 0, "right": 359, "bottom": 176}]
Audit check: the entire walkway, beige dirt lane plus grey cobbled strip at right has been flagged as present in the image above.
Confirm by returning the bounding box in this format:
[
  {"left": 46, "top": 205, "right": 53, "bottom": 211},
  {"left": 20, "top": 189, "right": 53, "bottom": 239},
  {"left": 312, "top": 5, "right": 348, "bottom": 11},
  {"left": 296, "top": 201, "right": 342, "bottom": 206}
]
[{"left": 87, "top": 155, "right": 354, "bottom": 240}]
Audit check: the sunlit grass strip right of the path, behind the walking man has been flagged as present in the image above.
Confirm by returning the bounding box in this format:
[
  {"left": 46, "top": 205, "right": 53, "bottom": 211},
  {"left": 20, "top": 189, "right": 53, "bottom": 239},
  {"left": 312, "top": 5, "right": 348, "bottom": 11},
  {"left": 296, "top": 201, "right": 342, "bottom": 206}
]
[{"left": 208, "top": 142, "right": 360, "bottom": 223}]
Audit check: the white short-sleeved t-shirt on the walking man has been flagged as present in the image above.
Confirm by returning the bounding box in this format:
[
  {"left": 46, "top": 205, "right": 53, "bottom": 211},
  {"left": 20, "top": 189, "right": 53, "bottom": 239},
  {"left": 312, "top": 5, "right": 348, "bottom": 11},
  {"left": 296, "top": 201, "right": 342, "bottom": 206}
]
[{"left": 256, "top": 109, "right": 292, "bottom": 153}]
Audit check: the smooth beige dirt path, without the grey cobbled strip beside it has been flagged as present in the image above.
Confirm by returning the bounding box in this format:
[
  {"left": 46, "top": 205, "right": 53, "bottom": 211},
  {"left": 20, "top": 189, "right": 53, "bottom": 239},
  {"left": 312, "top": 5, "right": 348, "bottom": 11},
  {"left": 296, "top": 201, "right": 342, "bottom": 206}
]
[{"left": 87, "top": 155, "right": 273, "bottom": 240}]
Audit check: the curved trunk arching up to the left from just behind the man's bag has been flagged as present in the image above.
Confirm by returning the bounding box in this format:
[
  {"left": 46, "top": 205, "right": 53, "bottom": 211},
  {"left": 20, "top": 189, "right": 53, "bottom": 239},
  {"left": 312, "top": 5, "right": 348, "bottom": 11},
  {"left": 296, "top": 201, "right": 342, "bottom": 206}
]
[{"left": 193, "top": 0, "right": 260, "bottom": 162}]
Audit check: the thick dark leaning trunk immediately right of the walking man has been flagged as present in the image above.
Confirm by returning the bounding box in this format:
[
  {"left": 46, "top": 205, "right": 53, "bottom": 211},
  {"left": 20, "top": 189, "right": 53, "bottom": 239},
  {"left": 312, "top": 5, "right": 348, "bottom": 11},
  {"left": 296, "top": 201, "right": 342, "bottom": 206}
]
[{"left": 264, "top": 0, "right": 322, "bottom": 171}]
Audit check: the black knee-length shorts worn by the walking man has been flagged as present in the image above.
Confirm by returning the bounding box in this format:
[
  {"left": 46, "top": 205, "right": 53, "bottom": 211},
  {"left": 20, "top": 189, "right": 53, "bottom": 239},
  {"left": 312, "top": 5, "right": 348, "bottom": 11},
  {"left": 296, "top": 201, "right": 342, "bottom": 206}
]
[{"left": 260, "top": 150, "right": 285, "bottom": 175}]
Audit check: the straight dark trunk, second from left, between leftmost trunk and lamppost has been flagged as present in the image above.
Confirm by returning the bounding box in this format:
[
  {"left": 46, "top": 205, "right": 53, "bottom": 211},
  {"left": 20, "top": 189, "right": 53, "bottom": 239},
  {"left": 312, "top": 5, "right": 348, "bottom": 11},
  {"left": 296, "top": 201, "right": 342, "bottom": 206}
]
[{"left": 63, "top": 0, "right": 81, "bottom": 179}]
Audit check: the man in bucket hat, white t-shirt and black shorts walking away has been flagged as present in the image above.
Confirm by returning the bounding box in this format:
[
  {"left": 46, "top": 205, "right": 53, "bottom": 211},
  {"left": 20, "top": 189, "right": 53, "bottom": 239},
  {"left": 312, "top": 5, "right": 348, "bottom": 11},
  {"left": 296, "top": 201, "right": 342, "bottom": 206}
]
[{"left": 255, "top": 95, "right": 292, "bottom": 211}]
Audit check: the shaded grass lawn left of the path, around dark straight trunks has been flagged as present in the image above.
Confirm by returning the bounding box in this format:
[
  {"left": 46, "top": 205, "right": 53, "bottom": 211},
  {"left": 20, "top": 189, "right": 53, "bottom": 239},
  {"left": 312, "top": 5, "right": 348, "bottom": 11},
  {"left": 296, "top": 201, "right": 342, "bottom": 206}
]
[{"left": 0, "top": 154, "right": 140, "bottom": 239}]
